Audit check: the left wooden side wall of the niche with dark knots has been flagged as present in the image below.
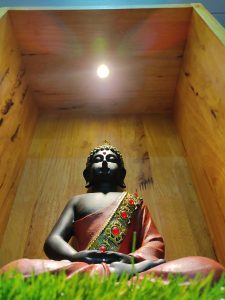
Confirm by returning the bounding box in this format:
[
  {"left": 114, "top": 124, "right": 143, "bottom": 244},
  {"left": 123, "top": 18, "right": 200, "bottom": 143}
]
[{"left": 0, "top": 15, "right": 37, "bottom": 242}]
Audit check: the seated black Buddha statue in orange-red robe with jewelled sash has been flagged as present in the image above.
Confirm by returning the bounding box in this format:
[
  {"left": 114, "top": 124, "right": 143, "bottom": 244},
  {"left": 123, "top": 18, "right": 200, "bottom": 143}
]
[{"left": 0, "top": 142, "right": 225, "bottom": 280}]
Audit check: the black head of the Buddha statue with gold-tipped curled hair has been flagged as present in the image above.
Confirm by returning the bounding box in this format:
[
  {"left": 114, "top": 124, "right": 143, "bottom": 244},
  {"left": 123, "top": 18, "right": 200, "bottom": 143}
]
[{"left": 83, "top": 141, "right": 126, "bottom": 188}]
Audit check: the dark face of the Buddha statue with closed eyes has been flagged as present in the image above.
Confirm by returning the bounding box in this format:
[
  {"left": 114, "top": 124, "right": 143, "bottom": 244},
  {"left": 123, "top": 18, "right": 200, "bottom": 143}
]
[{"left": 90, "top": 150, "right": 120, "bottom": 181}]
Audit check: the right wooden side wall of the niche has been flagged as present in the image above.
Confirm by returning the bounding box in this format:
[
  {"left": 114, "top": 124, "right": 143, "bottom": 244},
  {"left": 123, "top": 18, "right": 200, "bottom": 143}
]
[{"left": 175, "top": 7, "right": 225, "bottom": 264}]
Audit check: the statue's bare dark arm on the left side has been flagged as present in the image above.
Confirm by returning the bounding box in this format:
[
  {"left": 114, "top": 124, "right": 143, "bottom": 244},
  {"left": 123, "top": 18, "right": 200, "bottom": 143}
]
[{"left": 44, "top": 198, "right": 77, "bottom": 260}]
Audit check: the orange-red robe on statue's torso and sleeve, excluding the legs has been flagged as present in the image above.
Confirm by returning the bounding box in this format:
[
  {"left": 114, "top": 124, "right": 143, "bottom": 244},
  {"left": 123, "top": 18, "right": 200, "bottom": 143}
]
[{"left": 73, "top": 201, "right": 164, "bottom": 262}]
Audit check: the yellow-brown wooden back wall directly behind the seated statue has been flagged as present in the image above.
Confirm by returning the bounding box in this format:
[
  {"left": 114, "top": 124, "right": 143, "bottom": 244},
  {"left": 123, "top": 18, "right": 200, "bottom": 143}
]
[{"left": 0, "top": 114, "right": 215, "bottom": 265}]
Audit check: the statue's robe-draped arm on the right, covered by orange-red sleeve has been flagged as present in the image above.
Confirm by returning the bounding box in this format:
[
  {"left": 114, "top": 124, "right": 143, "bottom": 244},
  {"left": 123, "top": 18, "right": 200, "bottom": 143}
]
[{"left": 130, "top": 204, "right": 164, "bottom": 262}]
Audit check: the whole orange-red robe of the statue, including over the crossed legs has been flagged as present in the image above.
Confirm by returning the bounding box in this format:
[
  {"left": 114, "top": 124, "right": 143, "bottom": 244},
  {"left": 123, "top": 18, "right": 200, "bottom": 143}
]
[{"left": 0, "top": 200, "right": 225, "bottom": 280}]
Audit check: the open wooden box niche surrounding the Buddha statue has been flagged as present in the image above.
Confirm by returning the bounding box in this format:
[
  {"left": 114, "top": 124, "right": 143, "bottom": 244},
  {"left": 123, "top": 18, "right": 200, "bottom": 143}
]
[{"left": 0, "top": 4, "right": 225, "bottom": 266}]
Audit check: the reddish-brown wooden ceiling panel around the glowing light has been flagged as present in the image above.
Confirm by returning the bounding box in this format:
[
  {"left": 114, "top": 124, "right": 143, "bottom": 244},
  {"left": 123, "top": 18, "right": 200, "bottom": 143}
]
[{"left": 7, "top": 7, "right": 192, "bottom": 114}]
